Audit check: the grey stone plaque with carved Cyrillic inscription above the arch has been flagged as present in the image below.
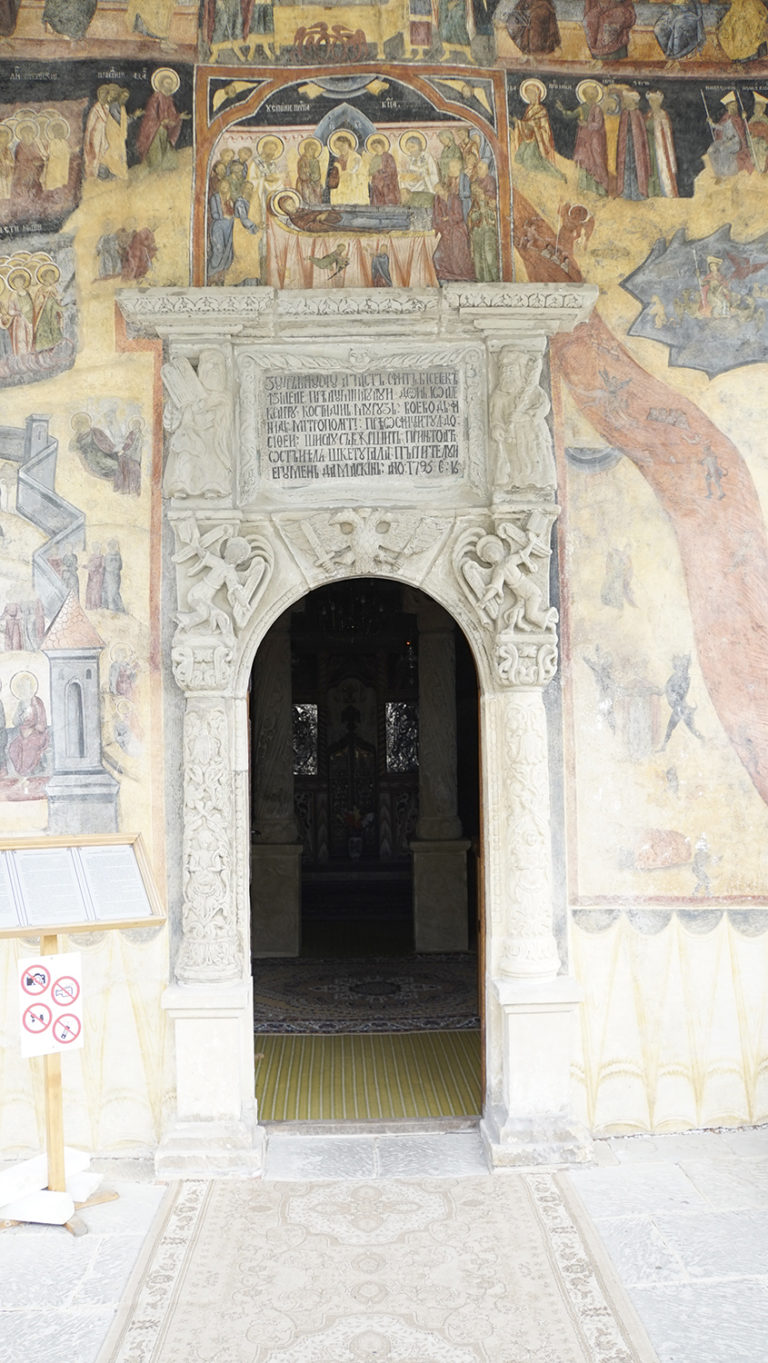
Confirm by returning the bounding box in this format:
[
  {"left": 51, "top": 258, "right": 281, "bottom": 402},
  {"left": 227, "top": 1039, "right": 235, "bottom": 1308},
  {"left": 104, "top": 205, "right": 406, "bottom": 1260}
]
[{"left": 262, "top": 367, "right": 462, "bottom": 488}]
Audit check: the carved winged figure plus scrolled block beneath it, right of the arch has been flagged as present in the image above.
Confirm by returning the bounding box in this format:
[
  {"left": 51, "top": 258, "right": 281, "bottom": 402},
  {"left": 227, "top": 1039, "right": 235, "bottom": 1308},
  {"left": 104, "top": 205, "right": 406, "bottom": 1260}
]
[{"left": 453, "top": 508, "right": 558, "bottom": 686}]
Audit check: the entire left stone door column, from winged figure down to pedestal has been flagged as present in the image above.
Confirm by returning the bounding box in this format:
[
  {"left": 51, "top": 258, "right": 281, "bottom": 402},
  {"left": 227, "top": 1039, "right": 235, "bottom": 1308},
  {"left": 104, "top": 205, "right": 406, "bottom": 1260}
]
[{"left": 156, "top": 512, "right": 271, "bottom": 1178}]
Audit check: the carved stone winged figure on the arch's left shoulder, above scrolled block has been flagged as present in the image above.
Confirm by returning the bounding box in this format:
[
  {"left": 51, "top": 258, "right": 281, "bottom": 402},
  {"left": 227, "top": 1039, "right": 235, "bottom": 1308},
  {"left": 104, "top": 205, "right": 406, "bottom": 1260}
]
[{"left": 173, "top": 517, "right": 267, "bottom": 642}]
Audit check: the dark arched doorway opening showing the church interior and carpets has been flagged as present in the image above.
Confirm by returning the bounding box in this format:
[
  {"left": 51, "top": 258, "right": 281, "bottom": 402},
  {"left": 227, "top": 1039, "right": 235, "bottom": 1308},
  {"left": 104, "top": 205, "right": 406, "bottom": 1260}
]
[{"left": 251, "top": 578, "right": 482, "bottom": 1122}]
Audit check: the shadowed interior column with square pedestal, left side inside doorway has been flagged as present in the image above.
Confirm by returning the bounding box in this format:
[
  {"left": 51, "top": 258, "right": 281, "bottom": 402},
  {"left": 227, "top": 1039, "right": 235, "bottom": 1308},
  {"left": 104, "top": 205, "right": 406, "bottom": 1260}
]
[{"left": 251, "top": 615, "right": 301, "bottom": 957}]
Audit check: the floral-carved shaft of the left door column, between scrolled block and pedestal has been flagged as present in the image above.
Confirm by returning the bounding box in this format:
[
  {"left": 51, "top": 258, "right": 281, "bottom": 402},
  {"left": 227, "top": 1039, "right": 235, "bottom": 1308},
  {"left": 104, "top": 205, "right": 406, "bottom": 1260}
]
[{"left": 176, "top": 699, "right": 240, "bottom": 983}]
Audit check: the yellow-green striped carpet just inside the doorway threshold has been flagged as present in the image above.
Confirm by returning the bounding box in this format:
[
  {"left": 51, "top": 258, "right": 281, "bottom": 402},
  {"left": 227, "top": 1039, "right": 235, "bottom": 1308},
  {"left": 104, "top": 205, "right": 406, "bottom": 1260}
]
[{"left": 255, "top": 1030, "right": 482, "bottom": 1122}]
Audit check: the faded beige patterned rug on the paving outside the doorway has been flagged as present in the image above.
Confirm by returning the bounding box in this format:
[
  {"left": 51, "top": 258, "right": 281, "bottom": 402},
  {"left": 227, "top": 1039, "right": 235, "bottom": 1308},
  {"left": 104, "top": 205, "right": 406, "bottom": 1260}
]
[{"left": 100, "top": 1172, "right": 656, "bottom": 1363}]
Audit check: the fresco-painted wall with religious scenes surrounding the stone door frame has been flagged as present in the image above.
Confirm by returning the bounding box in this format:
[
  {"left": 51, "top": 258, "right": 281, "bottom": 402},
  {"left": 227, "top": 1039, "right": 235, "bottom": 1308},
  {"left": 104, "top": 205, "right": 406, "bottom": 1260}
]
[{"left": 0, "top": 0, "right": 768, "bottom": 1149}]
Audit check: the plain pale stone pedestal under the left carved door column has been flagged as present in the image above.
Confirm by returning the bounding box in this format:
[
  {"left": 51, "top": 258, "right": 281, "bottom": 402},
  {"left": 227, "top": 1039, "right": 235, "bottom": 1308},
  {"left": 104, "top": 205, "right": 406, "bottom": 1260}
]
[{"left": 156, "top": 981, "right": 265, "bottom": 1178}]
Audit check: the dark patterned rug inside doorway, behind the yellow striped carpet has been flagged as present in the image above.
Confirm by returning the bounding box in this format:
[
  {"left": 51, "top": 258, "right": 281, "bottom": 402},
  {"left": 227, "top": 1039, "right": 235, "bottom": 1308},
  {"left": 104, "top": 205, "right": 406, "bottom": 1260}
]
[{"left": 254, "top": 953, "right": 480, "bottom": 1032}]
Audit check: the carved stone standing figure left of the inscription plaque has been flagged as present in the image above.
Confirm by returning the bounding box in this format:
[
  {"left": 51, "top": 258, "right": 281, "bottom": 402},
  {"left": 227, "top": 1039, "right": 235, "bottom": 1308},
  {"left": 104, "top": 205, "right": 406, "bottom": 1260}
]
[{"left": 162, "top": 349, "right": 232, "bottom": 497}]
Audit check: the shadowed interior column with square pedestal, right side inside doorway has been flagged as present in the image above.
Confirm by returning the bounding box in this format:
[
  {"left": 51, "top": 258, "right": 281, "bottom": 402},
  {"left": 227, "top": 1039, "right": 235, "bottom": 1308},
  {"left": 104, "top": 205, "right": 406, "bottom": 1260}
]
[{"left": 411, "top": 602, "right": 469, "bottom": 951}]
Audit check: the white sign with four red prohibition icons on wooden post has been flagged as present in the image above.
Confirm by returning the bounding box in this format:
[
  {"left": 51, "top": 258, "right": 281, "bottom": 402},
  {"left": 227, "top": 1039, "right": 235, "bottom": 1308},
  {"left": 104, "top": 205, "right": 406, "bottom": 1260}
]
[{"left": 19, "top": 951, "right": 85, "bottom": 1056}]
